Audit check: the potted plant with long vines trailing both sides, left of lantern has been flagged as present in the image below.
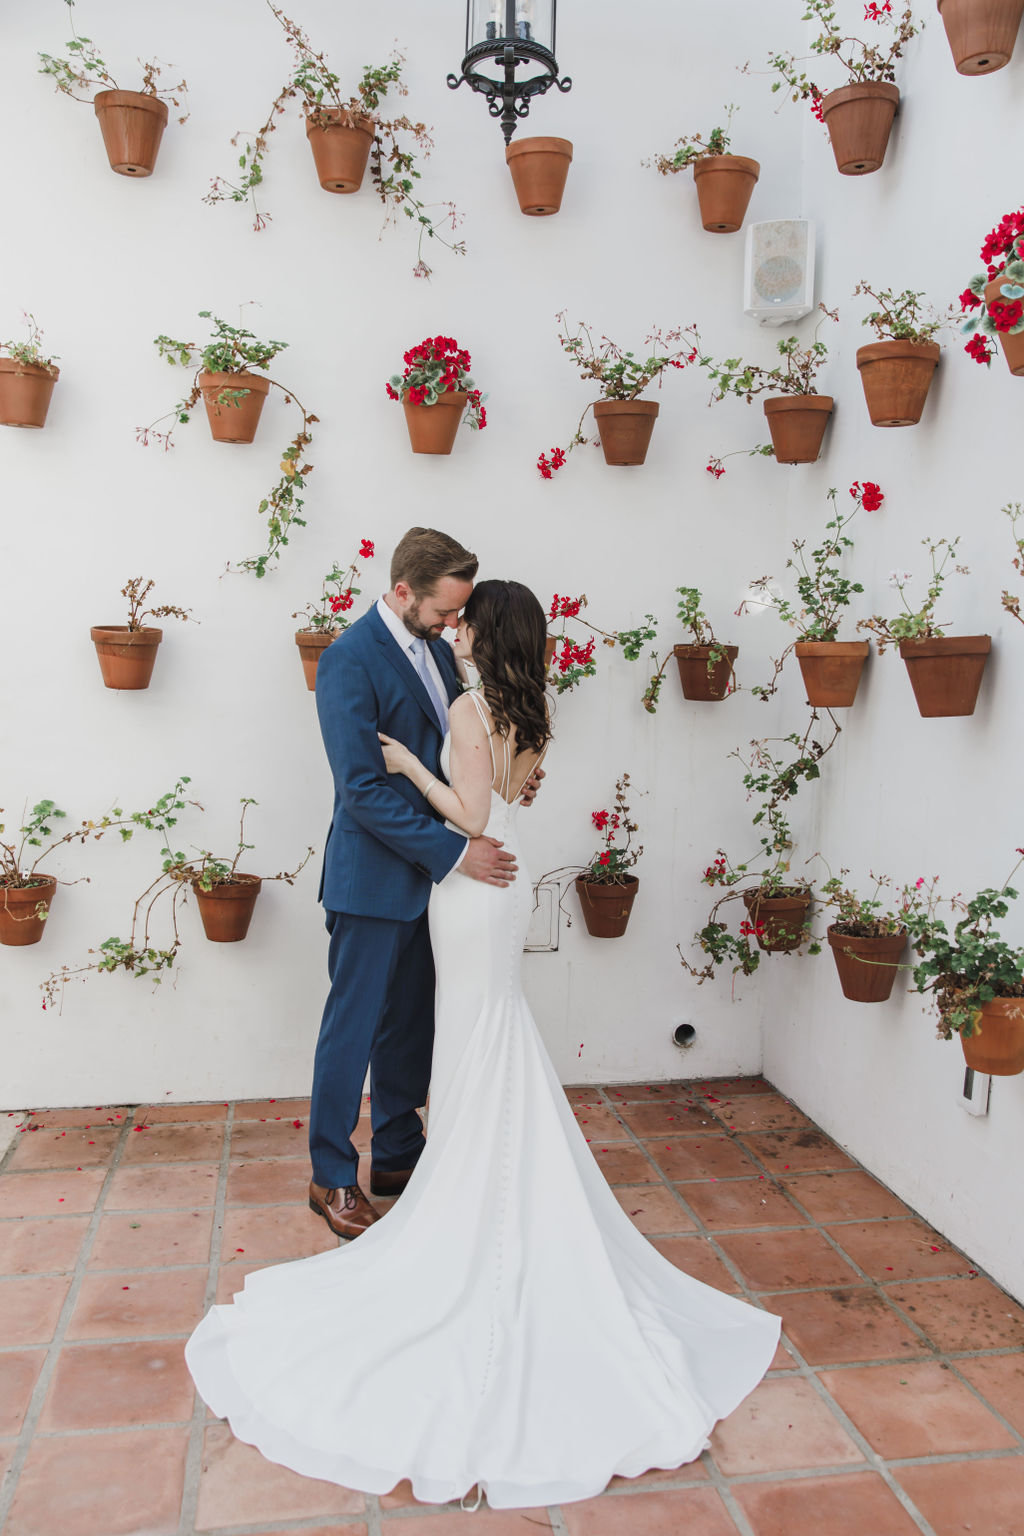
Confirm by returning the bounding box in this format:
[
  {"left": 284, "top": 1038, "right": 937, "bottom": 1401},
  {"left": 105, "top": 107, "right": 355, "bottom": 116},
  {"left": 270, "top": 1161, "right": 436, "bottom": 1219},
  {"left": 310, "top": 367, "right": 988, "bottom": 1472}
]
[{"left": 203, "top": 0, "right": 465, "bottom": 278}]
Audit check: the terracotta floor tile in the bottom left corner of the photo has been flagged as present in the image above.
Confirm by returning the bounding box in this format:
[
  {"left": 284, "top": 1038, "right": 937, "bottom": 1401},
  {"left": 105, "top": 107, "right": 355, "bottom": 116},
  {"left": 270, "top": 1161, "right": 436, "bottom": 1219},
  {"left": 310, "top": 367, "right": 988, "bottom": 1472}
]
[{"left": 5, "top": 1428, "right": 189, "bottom": 1536}]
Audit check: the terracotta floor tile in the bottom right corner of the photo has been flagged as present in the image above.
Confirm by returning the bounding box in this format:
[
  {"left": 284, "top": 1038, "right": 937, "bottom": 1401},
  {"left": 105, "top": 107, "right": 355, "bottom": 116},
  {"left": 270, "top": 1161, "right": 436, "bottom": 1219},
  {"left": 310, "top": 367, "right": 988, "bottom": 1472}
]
[{"left": 894, "top": 1456, "right": 1024, "bottom": 1536}]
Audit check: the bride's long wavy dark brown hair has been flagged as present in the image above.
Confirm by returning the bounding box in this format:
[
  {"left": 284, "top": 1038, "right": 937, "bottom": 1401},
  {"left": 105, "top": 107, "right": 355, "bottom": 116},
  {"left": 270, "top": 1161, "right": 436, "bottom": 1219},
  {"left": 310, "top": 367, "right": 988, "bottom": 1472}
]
[{"left": 462, "top": 581, "right": 551, "bottom": 756}]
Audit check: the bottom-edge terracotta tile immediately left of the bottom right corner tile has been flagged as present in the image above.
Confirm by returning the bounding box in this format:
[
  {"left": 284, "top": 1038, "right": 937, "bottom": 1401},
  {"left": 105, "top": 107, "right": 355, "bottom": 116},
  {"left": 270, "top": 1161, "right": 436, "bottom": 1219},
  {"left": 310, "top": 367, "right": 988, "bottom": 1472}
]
[{"left": 732, "top": 1471, "right": 920, "bottom": 1536}]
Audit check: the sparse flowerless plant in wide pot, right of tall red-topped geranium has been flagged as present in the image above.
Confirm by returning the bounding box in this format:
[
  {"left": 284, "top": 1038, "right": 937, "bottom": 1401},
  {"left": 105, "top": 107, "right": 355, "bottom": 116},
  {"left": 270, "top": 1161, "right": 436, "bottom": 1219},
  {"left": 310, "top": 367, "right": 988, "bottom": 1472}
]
[{"left": 857, "top": 535, "right": 992, "bottom": 719}]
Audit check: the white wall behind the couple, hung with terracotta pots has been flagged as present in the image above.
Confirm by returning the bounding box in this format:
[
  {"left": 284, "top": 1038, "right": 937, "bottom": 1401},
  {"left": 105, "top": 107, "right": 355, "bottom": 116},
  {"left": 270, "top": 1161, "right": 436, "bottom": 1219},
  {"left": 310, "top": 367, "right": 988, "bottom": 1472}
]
[{"left": 0, "top": 0, "right": 1024, "bottom": 1293}]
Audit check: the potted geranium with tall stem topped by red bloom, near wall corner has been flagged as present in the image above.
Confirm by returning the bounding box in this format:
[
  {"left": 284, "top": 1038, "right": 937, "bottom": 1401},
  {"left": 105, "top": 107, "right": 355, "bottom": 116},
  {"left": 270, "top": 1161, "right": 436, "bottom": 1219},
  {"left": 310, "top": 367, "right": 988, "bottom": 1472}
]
[{"left": 737, "top": 481, "right": 886, "bottom": 710}]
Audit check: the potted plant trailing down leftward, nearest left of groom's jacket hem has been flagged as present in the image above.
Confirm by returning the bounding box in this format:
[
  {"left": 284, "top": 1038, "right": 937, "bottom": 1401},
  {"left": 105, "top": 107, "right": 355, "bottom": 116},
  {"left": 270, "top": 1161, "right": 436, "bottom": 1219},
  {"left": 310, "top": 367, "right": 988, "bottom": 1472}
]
[{"left": 40, "top": 774, "right": 313, "bottom": 1008}]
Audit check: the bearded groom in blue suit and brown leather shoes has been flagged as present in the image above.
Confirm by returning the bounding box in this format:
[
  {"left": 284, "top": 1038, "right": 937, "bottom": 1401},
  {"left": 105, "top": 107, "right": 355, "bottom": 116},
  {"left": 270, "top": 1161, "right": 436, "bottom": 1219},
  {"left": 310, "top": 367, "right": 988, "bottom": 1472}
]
[{"left": 309, "top": 528, "right": 516, "bottom": 1238}]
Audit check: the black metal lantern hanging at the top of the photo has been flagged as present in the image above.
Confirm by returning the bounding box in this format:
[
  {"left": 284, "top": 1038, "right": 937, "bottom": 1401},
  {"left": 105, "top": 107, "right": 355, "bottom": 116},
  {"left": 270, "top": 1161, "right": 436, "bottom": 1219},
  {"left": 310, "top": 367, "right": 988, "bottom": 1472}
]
[{"left": 448, "top": 0, "right": 573, "bottom": 144}]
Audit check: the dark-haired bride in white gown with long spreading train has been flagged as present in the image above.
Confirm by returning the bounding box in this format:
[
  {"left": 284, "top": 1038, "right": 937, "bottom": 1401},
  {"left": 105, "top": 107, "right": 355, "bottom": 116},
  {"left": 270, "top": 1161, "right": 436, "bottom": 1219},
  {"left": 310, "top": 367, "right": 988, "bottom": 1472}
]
[{"left": 186, "top": 581, "right": 780, "bottom": 1508}]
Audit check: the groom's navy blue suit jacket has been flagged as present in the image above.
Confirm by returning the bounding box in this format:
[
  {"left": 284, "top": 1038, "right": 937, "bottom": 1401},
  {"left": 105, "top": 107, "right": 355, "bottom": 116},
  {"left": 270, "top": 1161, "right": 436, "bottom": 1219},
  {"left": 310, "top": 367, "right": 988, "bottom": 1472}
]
[{"left": 316, "top": 605, "right": 465, "bottom": 922}]
